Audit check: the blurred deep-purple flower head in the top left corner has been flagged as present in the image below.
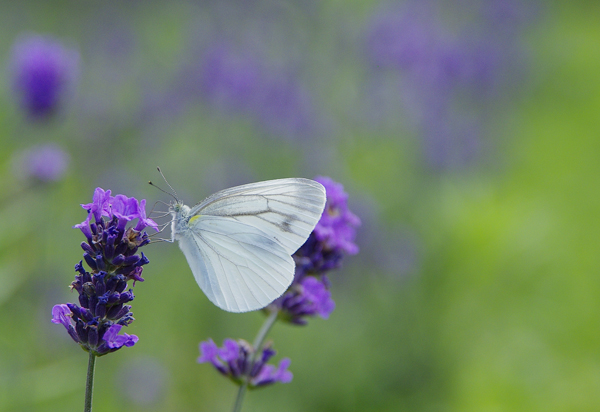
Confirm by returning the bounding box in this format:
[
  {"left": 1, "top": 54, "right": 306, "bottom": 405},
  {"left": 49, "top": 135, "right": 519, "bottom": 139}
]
[{"left": 10, "top": 34, "right": 79, "bottom": 119}]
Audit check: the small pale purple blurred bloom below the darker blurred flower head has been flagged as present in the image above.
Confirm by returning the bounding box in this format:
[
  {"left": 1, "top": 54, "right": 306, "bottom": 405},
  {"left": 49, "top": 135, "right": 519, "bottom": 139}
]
[{"left": 15, "top": 143, "right": 70, "bottom": 182}]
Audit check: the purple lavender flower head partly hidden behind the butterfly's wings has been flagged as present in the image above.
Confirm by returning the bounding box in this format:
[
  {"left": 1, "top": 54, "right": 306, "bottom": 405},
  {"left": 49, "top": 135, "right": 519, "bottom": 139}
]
[{"left": 274, "top": 176, "right": 360, "bottom": 325}]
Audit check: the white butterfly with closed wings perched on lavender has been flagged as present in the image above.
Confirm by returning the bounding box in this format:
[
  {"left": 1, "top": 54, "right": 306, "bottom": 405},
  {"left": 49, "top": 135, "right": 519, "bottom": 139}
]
[{"left": 169, "top": 179, "right": 326, "bottom": 312}]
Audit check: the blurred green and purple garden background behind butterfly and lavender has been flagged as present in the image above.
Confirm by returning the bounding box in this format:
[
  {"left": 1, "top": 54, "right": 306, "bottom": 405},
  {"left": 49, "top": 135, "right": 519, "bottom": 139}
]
[{"left": 0, "top": 0, "right": 600, "bottom": 412}]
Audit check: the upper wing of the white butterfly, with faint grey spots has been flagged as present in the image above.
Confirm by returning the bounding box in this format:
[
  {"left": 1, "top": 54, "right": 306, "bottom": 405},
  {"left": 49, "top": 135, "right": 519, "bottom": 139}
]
[{"left": 190, "top": 179, "right": 326, "bottom": 255}]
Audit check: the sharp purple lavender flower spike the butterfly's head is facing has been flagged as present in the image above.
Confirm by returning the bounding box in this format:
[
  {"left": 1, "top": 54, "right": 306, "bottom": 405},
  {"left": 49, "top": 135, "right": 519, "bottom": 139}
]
[{"left": 52, "top": 188, "right": 158, "bottom": 356}]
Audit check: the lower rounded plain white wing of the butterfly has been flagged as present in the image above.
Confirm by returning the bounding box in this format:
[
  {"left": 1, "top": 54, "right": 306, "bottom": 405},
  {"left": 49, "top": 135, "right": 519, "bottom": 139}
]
[{"left": 179, "top": 215, "right": 294, "bottom": 312}]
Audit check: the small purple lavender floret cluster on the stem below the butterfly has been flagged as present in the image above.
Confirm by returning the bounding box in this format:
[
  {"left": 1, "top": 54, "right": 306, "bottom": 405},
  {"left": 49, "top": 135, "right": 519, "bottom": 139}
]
[{"left": 198, "top": 339, "right": 292, "bottom": 388}]
